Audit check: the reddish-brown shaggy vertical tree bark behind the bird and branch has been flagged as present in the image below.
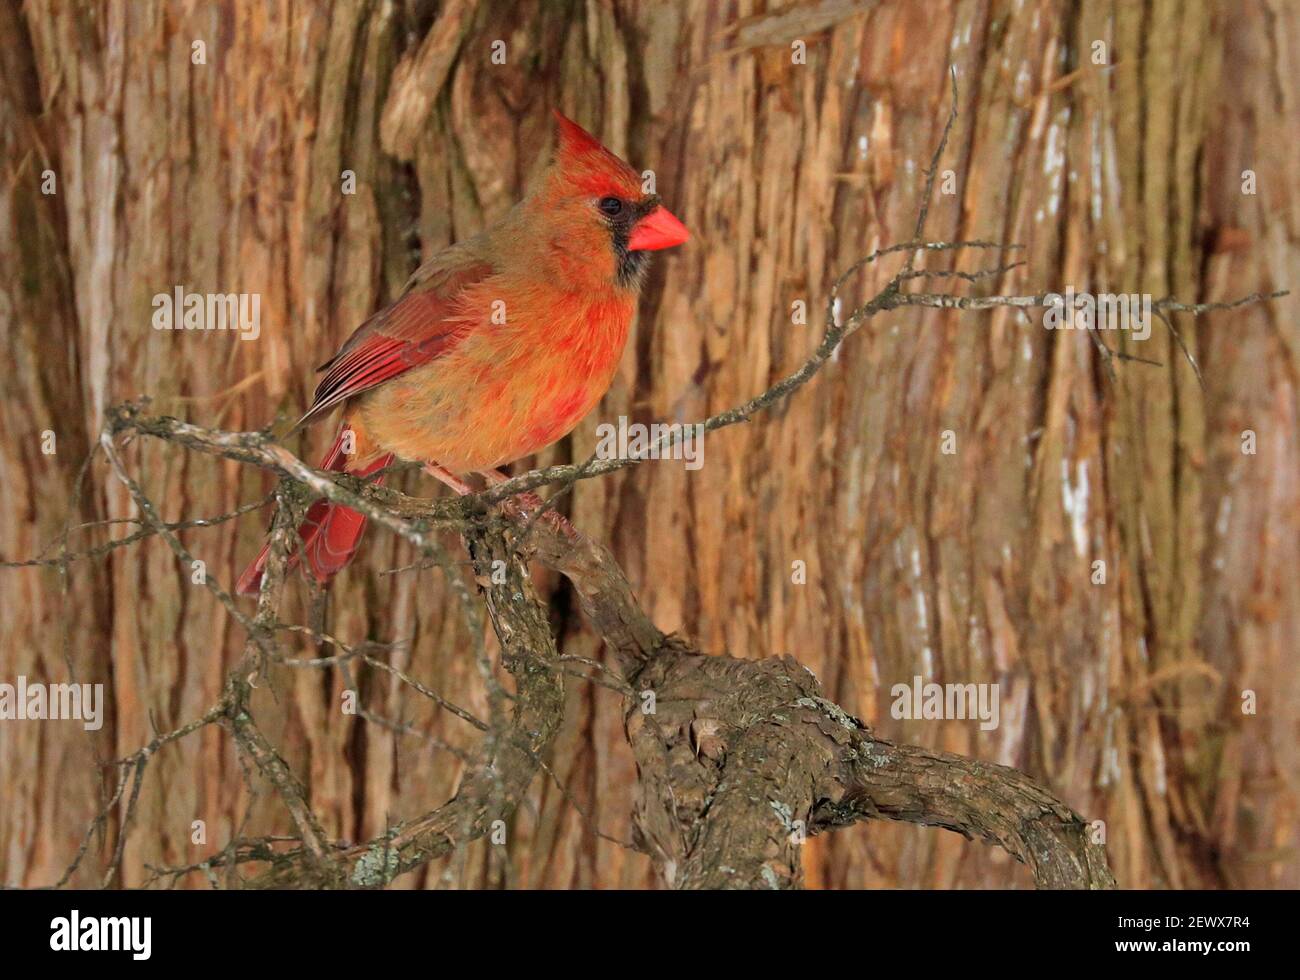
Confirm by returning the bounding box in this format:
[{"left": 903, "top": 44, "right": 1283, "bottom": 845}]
[{"left": 0, "top": 0, "right": 1300, "bottom": 888}]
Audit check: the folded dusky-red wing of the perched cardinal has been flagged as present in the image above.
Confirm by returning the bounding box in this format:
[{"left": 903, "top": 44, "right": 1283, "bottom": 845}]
[{"left": 294, "top": 250, "right": 493, "bottom": 429}]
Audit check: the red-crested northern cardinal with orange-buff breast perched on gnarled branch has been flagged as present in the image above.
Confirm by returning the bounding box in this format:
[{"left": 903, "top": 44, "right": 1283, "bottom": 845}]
[{"left": 238, "top": 112, "right": 689, "bottom": 594}]
